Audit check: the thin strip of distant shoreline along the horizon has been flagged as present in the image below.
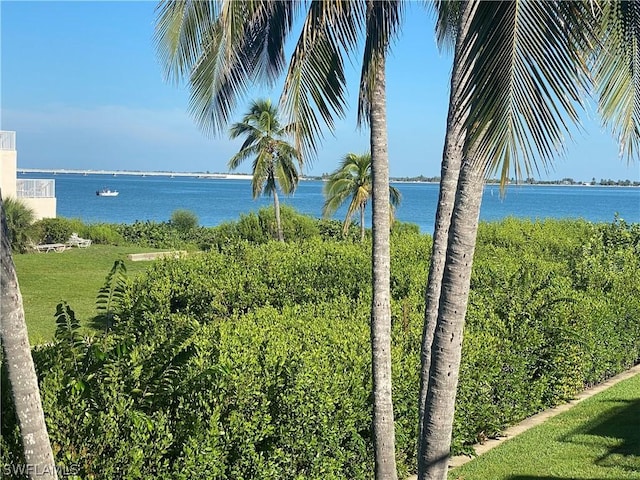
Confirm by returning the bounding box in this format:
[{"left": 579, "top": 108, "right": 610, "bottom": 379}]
[{"left": 17, "top": 168, "right": 640, "bottom": 187}]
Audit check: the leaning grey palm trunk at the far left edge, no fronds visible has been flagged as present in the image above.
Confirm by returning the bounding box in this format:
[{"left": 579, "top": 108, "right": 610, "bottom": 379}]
[{"left": 0, "top": 199, "right": 57, "bottom": 479}]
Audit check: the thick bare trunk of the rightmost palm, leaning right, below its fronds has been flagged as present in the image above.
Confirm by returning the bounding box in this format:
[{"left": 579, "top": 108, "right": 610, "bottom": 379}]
[{"left": 418, "top": 163, "right": 484, "bottom": 480}]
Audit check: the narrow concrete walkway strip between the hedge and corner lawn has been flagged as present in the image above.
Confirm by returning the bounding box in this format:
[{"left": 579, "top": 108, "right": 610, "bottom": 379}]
[{"left": 407, "top": 365, "right": 640, "bottom": 480}]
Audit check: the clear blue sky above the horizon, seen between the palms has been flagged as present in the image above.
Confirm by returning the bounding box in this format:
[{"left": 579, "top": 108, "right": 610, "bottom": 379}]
[{"left": 0, "top": 0, "right": 640, "bottom": 180}]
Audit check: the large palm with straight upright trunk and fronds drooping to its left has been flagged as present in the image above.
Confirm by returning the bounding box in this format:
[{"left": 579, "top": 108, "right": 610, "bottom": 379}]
[{"left": 156, "top": 0, "right": 402, "bottom": 479}]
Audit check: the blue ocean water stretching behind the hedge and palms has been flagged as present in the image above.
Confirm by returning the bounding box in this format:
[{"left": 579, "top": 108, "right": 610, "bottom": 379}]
[{"left": 18, "top": 173, "right": 640, "bottom": 233}]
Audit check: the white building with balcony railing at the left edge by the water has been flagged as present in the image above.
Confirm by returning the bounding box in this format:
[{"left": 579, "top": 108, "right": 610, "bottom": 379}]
[{"left": 0, "top": 130, "right": 56, "bottom": 220}]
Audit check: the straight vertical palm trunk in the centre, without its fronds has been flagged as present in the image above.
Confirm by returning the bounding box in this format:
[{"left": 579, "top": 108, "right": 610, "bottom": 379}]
[{"left": 369, "top": 55, "right": 397, "bottom": 480}]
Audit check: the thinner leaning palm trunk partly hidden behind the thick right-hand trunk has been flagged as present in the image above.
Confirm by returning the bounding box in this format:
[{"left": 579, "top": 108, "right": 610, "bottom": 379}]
[{"left": 418, "top": 0, "right": 471, "bottom": 470}]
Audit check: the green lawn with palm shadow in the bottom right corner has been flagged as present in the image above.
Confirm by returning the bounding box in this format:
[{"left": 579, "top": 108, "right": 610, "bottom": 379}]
[{"left": 449, "top": 375, "right": 640, "bottom": 480}]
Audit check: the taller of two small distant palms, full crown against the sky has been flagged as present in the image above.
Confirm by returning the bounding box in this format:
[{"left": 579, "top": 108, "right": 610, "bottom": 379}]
[{"left": 229, "top": 100, "right": 302, "bottom": 242}]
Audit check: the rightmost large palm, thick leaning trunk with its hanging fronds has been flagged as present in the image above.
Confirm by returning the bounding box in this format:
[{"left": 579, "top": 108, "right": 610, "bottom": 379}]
[{"left": 418, "top": 1, "right": 640, "bottom": 479}]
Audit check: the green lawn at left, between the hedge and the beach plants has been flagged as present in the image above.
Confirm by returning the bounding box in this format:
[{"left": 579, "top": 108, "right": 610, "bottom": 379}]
[{"left": 13, "top": 245, "right": 160, "bottom": 345}]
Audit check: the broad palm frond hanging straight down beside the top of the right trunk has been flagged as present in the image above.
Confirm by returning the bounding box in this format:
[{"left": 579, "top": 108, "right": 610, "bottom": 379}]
[{"left": 462, "top": 0, "right": 590, "bottom": 184}]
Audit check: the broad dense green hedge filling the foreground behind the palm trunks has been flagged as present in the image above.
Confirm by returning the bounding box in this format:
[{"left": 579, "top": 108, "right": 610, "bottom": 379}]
[{"left": 2, "top": 219, "right": 640, "bottom": 479}]
